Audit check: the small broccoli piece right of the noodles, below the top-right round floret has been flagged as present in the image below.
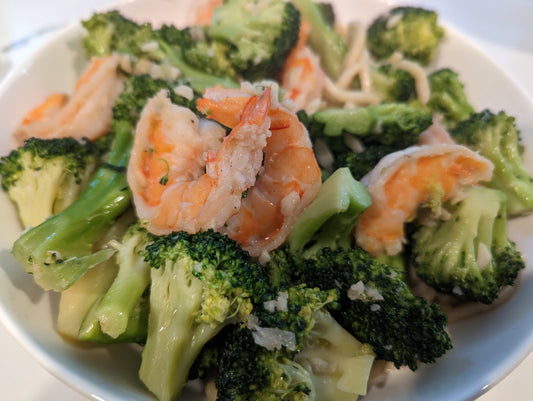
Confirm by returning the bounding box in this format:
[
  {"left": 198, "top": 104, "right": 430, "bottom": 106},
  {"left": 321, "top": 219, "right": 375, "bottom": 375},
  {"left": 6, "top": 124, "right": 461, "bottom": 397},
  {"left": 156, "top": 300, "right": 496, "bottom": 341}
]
[{"left": 370, "top": 64, "right": 416, "bottom": 103}]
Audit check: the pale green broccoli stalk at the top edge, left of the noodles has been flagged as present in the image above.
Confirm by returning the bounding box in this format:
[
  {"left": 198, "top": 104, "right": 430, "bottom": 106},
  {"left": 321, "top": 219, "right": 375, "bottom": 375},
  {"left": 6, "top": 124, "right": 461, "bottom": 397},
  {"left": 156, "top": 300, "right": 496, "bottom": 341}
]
[{"left": 292, "top": 0, "right": 347, "bottom": 79}]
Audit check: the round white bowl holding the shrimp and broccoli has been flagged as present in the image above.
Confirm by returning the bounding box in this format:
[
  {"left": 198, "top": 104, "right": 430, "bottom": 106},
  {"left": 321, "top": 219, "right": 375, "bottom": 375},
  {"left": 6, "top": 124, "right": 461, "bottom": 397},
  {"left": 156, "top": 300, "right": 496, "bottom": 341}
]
[{"left": 0, "top": 0, "right": 533, "bottom": 401}]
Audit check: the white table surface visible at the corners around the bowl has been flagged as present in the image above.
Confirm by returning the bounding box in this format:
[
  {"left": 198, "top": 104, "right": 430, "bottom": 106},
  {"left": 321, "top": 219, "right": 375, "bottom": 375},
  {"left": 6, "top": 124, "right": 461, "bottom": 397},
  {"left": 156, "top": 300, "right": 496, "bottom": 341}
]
[{"left": 0, "top": 0, "right": 533, "bottom": 401}]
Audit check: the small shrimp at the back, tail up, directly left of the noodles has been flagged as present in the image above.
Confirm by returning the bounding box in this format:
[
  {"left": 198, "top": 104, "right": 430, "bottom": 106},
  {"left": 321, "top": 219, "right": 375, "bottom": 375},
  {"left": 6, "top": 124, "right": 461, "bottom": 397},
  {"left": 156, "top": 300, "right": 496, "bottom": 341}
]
[{"left": 280, "top": 22, "right": 326, "bottom": 113}]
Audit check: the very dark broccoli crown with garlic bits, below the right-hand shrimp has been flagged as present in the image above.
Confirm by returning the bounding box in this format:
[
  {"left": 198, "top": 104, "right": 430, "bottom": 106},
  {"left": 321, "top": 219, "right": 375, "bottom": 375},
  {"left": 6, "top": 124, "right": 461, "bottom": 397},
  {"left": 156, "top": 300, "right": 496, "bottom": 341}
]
[{"left": 269, "top": 246, "right": 452, "bottom": 370}]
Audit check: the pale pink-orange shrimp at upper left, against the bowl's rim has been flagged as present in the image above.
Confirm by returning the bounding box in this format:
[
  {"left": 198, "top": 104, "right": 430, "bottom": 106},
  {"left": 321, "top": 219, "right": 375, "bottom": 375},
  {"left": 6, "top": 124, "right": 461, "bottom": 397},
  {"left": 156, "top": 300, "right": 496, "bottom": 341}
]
[{"left": 14, "top": 54, "right": 124, "bottom": 143}]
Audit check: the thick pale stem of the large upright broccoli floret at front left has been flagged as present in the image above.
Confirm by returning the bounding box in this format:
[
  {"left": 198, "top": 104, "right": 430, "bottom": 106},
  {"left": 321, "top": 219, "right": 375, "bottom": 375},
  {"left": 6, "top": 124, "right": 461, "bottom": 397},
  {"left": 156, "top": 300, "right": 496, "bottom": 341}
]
[{"left": 139, "top": 260, "right": 223, "bottom": 401}]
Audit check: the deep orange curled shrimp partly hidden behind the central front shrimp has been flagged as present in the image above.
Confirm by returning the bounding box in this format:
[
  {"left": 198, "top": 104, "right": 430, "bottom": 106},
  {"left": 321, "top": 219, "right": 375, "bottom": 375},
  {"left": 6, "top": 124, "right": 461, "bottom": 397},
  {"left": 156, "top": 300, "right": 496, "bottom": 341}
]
[{"left": 198, "top": 83, "right": 321, "bottom": 256}]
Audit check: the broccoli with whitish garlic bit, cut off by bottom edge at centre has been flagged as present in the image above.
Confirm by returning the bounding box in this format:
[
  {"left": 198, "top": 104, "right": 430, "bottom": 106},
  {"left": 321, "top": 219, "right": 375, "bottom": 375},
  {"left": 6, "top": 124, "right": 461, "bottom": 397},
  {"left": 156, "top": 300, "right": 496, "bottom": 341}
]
[{"left": 216, "top": 286, "right": 374, "bottom": 401}]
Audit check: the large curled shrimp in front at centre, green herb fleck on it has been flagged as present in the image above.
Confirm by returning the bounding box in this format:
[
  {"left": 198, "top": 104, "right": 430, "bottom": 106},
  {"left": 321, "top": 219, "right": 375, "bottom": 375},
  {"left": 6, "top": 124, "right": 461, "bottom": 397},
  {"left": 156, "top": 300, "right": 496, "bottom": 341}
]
[{"left": 127, "top": 89, "right": 270, "bottom": 235}]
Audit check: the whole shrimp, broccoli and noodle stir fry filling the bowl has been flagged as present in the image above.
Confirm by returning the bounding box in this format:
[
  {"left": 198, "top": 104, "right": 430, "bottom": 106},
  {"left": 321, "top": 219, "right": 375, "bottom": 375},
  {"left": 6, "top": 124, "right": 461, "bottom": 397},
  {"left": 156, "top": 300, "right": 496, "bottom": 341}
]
[{"left": 0, "top": 0, "right": 533, "bottom": 401}]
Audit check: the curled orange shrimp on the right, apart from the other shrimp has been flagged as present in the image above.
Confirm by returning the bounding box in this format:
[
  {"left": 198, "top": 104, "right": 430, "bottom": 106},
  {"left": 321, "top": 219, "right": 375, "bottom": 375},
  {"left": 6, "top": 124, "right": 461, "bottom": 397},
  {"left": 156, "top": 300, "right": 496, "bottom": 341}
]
[{"left": 355, "top": 144, "right": 494, "bottom": 255}]
